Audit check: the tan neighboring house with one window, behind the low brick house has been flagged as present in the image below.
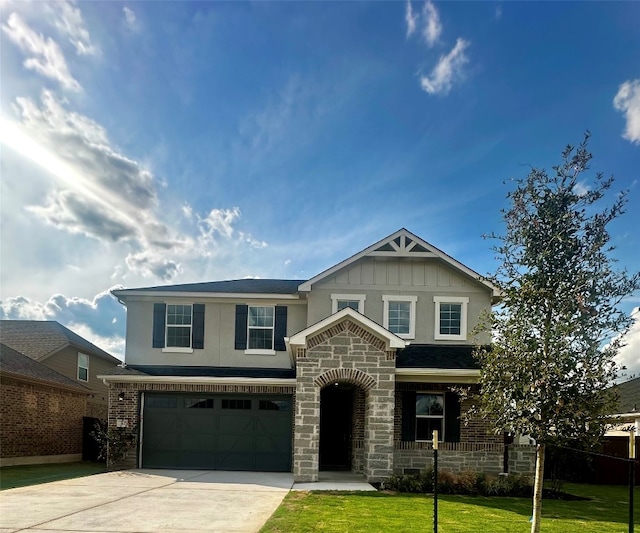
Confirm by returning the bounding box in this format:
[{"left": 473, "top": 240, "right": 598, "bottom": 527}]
[{"left": 0, "top": 320, "right": 121, "bottom": 420}]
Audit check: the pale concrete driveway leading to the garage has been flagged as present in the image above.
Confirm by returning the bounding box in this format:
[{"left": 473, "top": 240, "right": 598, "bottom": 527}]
[{"left": 0, "top": 469, "right": 293, "bottom": 533}]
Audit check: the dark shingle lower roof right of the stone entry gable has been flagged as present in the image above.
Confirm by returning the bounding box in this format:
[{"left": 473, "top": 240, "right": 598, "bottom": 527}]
[{"left": 396, "top": 344, "right": 479, "bottom": 370}]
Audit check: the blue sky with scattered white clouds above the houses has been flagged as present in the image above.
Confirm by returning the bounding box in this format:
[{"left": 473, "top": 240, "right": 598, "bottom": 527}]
[{"left": 0, "top": 0, "right": 640, "bottom": 374}]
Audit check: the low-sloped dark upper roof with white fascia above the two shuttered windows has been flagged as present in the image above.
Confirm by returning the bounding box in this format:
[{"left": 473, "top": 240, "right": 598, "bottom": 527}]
[{"left": 111, "top": 278, "right": 303, "bottom": 299}]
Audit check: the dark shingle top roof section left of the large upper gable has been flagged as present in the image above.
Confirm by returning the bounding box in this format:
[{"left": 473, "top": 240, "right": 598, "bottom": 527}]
[{"left": 114, "top": 279, "right": 305, "bottom": 295}]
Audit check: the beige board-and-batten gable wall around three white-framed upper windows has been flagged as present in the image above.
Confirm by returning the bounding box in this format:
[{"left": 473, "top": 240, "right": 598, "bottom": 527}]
[{"left": 307, "top": 257, "right": 491, "bottom": 344}]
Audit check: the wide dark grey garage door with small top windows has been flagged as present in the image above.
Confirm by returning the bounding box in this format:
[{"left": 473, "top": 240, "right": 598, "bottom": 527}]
[{"left": 142, "top": 393, "right": 293, "bottom": 472}]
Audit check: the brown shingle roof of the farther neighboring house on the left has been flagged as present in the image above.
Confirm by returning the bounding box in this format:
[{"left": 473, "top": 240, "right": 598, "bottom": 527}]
[{"left": 0, "top": 320, "right": 120, "bottom": 364}]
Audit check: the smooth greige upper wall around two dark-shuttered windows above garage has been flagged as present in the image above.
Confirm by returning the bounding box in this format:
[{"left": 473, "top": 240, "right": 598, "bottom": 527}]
[{"left": 125, "top": 297, "right": 307, "bottom": 368}]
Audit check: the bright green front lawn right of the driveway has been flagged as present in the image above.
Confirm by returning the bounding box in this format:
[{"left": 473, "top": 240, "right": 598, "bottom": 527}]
[{"left": 260, "top": 484, "right": 640, "bottom": 533}]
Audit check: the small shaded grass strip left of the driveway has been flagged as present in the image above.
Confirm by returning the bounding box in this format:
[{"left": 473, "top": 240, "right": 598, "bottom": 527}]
[{"left": 0, "top": 461, "right": 106, "bottom": 490}]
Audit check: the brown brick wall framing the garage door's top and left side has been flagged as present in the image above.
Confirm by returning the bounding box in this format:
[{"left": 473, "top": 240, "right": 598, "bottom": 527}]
[{"left": 108, "top": 382, "right": 295, "bottom": 469}]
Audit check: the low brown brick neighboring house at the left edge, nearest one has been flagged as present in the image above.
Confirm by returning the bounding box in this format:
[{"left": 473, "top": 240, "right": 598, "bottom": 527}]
[{"left": 0, "top": 344, "right": 90, "bottom": 466}]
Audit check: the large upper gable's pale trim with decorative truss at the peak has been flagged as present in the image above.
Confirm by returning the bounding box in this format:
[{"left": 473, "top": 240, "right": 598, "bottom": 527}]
[{"left": 298, "top": 228, "right": 499, "bottom": 301}]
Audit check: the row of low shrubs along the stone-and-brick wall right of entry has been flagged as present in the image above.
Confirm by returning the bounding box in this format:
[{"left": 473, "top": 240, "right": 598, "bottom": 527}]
[{"left": 382, "top": 470, "right": 532, "bottom": 496}]
